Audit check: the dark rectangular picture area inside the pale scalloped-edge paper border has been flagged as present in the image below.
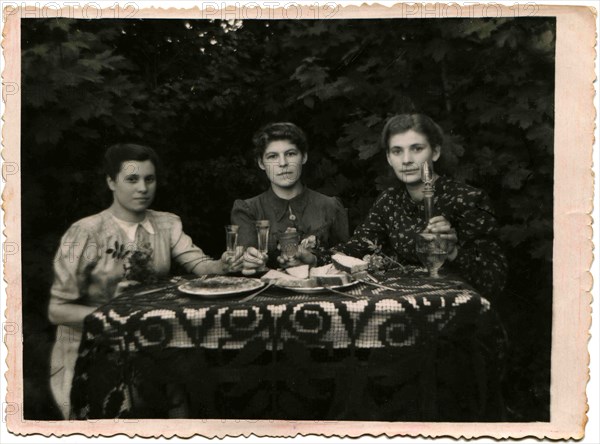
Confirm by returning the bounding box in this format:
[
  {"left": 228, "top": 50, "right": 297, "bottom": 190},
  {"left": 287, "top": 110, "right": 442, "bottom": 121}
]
[{"left": 2, "top": 4, "right": 593, "bottom": 440}]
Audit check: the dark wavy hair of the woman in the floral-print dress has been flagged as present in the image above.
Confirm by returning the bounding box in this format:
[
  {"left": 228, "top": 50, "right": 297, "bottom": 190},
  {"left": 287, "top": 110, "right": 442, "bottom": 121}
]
[{"left": 379, "top": 114, "right": 444, "bottom": 152}]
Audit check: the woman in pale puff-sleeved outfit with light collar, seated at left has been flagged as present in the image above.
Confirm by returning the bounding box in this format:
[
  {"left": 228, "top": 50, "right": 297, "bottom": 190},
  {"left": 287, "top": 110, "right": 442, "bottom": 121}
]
[{"left": 48, "top": 144, "right": 242, "bottom": 419}]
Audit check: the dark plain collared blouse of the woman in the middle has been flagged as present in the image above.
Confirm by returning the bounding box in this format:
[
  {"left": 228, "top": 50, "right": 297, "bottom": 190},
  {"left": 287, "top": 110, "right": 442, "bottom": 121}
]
[{"left": 231, "top": 187, "right": 349, "bottom": 266}]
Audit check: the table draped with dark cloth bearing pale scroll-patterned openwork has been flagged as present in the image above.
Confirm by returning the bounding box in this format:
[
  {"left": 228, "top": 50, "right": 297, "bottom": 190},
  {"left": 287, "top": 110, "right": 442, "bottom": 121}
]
[{"left": 71, "top": 268, "right": 504, "bottom": 421}]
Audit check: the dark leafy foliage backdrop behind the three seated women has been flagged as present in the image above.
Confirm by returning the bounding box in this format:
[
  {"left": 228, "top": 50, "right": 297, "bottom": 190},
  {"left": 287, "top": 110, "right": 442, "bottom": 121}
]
[{"left": 21, "top": 18, "right": 555, "bottom": 421}]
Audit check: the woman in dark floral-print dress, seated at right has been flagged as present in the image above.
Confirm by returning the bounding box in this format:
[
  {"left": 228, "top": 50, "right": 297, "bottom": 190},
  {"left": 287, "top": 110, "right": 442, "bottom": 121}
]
[{"left": 336, "top": 114, "right": 507, "bottom": 296}]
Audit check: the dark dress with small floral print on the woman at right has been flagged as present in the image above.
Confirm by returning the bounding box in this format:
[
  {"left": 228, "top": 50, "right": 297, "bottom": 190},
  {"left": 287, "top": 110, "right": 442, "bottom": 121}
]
[{"left": 335, "top": 176, "right": 507, "bottom": 297}]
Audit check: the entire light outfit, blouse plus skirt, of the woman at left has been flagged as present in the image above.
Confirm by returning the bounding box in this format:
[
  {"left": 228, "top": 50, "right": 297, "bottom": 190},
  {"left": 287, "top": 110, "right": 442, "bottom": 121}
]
[{"left": 50, "top": 210, "right": 212, "bottom": 419}]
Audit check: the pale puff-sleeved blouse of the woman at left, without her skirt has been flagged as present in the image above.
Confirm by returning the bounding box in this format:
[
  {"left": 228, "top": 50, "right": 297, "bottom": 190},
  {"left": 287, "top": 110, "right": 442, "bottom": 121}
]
[{"left": 50, "top": 210, "right": 212, "bottom": 307}]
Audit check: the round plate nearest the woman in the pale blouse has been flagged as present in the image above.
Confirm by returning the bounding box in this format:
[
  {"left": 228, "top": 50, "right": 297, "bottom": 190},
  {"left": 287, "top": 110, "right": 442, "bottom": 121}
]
[{"left": 177, "top": 276, "right": 265, "bottom": 298}]
